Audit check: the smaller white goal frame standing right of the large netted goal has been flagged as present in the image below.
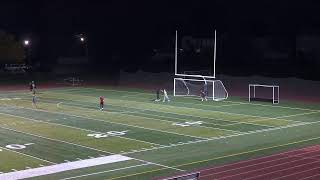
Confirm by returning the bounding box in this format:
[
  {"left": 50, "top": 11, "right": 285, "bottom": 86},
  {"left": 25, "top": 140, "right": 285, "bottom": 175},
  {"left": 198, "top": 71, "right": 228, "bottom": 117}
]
[{"left": 248, "top": 84, "right": 280, "bottom": 104}]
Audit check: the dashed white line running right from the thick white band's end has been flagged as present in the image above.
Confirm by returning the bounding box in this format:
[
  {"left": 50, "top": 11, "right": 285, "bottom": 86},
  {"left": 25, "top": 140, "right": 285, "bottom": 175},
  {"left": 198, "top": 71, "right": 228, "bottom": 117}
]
[{"left": 121, "top": 121, "right": 320, "bottom": 154}]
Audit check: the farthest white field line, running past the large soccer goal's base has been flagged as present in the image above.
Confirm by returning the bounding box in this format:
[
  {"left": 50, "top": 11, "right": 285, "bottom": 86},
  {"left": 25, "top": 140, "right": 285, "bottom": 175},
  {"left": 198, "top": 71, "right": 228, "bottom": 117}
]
[{"left": 74, "top": 87, "right": 320, "bottom": 112}]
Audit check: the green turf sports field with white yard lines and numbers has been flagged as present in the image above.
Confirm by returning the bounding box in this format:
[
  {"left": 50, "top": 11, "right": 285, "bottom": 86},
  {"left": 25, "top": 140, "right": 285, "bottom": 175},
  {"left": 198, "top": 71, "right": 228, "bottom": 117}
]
[{"left": 0, "top": 87, "right": 320, "bottom": 180}]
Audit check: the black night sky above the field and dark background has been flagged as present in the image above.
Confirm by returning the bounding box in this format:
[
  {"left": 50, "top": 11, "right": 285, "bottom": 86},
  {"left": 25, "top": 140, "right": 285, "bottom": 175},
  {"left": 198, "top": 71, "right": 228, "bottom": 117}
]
[{"left": 0, "top": 0, "right": 320, "bottom": 78}]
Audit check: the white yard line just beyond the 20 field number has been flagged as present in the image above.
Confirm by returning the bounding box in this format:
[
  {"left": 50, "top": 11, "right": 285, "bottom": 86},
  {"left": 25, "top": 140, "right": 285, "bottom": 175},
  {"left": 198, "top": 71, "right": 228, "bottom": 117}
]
[{"left": 1, "top": 102, "right": 209, "bottom": 139}]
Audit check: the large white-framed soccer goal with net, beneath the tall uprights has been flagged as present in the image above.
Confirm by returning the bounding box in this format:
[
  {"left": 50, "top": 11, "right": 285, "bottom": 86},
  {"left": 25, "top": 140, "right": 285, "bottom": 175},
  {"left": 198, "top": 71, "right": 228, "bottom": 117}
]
[{"left": 173, "top": 78, "right": 228, "bottom": 101}]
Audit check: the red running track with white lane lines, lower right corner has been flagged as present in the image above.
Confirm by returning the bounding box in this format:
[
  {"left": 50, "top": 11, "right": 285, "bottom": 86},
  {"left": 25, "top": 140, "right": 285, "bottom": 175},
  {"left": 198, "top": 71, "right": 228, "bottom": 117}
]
[{"left": 200, "top": 145, "right": 320, "bottom": 180}]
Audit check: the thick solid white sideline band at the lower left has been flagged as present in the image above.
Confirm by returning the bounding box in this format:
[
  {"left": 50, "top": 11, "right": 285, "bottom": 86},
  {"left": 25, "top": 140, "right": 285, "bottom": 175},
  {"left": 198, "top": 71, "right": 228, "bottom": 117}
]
[{"left": 0, "top": 155, "right": 132, "bottom": 180}]
